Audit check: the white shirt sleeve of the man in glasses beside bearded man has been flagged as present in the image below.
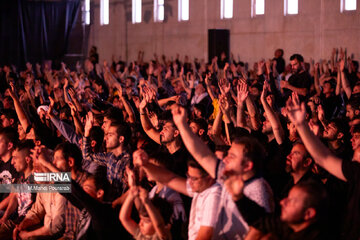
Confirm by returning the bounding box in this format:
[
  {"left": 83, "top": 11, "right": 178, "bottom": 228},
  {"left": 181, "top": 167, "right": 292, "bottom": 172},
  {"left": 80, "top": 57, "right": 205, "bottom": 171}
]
[{"left": 200, "top": 185, "right": 221, "bottom": 227}]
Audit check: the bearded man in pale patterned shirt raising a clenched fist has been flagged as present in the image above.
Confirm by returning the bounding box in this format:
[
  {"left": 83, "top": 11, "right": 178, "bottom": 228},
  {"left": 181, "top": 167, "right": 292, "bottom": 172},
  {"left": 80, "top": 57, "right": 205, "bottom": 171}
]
[{"left": 172, "top": 106, "right": 274, "bottom": 239}]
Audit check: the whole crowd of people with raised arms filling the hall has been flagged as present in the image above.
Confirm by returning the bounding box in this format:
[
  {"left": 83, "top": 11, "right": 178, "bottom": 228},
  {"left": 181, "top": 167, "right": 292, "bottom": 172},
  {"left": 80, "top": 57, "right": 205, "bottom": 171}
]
[{"left": 0, "top": 47, "right": 360, "bottom": 240}]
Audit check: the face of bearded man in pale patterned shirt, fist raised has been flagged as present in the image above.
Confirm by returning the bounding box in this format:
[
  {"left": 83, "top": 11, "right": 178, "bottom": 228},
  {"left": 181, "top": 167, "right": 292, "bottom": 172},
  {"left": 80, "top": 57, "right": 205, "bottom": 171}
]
[{"left": 224, "top": 143, "right": 248, "bottom": 174}]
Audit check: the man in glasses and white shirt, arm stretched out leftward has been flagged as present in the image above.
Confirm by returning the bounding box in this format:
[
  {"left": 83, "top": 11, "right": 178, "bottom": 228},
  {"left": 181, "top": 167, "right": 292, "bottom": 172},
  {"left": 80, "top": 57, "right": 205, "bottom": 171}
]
[{"left": 134, "top": 150, "right": 221, "bottom": 239}]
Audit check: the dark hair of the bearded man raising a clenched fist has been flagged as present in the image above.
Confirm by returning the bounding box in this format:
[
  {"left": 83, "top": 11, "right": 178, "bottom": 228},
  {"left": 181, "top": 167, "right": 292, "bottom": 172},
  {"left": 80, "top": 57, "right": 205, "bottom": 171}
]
[{"left": 232, "top": 137, "right": 266, "bottom": 171}]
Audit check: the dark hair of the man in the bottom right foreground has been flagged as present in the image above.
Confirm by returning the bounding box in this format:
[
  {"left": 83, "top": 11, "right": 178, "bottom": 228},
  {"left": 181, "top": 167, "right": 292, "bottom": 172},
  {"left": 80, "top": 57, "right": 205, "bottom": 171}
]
[{"left": 294, "top": 180, "right": 329, "bottom": 220}]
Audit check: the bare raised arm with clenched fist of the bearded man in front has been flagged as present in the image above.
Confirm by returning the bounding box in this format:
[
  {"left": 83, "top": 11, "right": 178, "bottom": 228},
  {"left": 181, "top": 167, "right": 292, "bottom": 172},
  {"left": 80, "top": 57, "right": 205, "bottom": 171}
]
[{"left": 172, "top": 105, "right": 218, "bottom": 178}]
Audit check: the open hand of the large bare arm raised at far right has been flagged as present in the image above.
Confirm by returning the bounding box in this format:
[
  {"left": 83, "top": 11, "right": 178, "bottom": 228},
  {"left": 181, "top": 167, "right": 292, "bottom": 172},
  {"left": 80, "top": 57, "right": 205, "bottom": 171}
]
[{"left": 286, "top": 92, "right": 306, "bottom": 125}]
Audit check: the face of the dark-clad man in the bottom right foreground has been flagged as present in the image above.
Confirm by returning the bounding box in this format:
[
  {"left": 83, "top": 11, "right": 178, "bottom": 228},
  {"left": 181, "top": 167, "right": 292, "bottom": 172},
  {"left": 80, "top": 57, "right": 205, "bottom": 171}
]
[{"left": 280, "top": 187, "right": 307, "bottom": 224}]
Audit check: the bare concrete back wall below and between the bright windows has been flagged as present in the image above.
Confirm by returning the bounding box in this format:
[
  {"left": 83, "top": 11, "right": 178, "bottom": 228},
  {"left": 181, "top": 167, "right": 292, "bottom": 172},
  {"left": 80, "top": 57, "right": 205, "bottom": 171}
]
[{"left": 89, "top": 0, "right": 360, "bottom": 64}]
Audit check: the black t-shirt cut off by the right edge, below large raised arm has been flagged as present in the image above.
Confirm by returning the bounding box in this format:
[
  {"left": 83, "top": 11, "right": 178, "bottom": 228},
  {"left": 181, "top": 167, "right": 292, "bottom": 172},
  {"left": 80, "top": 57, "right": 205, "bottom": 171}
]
[{"left": 342, "top": 160, "right": 360, "bottom": 240}]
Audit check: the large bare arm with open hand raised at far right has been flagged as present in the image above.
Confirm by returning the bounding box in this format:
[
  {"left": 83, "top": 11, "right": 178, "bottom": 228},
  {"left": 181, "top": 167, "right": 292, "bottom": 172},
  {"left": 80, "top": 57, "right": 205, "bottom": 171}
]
[{"left": 287, "top": 93, "right": 346, "bottom": 181}]
